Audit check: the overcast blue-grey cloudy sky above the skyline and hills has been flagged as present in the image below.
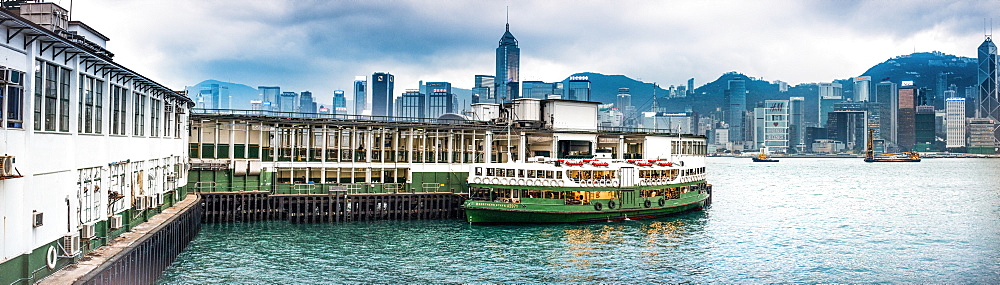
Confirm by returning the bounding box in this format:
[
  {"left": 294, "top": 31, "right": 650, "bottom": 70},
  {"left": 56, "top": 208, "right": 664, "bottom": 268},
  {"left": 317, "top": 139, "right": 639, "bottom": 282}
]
[{"left": 68, "top": 0, "right": 1000, "bottom": 101}]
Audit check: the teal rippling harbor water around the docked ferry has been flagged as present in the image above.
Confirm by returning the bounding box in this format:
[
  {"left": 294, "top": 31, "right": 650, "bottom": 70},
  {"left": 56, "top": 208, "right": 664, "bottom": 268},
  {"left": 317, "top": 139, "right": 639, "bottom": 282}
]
[{"left": 159, "top": 158, "right": 1000, "bottom": 284}]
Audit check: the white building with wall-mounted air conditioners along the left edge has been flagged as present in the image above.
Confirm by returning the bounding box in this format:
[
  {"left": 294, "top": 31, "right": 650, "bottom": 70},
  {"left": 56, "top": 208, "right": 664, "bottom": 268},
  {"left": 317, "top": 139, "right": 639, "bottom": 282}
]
[{"left": 0, "top": 2, "right": 193, "bottom": 284}]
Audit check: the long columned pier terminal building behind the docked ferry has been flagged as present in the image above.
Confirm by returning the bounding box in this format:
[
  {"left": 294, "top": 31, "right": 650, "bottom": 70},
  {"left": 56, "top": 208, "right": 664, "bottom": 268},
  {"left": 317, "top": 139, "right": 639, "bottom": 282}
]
[{"left": 188, "top": 98, "right": 706, "bottom": 194}]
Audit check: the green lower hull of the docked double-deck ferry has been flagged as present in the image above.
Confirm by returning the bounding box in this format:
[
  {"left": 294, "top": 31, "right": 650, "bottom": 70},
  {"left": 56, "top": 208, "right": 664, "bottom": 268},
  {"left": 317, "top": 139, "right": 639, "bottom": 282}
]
[{"left": 465, "top": 197, "right": 707, "bottom": 224}]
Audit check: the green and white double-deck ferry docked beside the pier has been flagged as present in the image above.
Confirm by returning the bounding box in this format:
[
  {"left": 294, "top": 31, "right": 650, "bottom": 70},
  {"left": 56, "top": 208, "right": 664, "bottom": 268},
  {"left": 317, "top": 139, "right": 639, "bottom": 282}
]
[{"left": 463, "top": 159, "right": 712, "bottom": 223}]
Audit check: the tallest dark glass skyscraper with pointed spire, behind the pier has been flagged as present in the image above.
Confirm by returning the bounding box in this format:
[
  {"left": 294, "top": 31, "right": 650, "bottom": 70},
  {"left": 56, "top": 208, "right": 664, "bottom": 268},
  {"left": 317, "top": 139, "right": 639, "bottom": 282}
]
[{"left": 493, "top": 19, "right": 521, "bottom": 103}]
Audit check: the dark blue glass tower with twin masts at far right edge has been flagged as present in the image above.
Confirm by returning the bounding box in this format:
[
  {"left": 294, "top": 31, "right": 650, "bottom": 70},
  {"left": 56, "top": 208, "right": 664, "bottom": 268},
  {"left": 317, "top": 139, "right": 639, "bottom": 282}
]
[{"left": 977, "top": 36, "right": 1000, "bottom": 145}]
